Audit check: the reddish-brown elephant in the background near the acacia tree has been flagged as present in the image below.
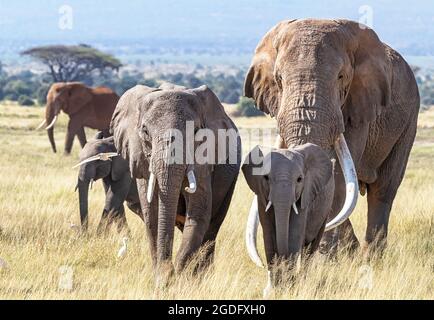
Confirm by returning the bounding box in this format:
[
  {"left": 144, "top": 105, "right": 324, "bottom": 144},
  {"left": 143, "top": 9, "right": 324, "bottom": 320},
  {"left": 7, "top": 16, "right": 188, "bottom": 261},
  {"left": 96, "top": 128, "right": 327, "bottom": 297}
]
[{"left": 38, "top": 82, "right": 119, "bottom": 154}]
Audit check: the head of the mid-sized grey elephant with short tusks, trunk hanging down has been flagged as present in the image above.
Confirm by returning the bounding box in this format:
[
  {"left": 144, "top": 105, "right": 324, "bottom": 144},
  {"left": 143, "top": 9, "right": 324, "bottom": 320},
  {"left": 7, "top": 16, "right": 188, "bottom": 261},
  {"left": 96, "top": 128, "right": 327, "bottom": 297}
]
[{"left": 111, "top": 86, "right": 231, "bottom": 272}]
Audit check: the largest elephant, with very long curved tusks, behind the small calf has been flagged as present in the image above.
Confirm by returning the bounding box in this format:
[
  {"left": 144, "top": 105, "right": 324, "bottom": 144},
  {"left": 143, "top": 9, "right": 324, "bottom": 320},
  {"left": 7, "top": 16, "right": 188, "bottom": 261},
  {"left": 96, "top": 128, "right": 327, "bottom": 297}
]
[{"left": 244, "top": 19, "right": 419, "bottom": 256}]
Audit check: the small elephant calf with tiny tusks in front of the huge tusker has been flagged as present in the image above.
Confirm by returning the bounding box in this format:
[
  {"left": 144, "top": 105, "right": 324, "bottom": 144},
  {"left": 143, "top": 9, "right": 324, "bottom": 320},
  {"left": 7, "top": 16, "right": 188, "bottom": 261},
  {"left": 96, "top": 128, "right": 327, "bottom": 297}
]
[{"left": 242, "top": 143, "right": 334, "bottom": 293}]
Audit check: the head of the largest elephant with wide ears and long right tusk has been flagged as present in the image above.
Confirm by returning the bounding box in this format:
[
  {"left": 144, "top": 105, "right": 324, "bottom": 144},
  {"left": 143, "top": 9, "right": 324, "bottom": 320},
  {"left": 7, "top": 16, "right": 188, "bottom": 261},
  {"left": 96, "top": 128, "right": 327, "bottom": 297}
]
[{"left": 244, "top": 19, "right": 391, "bottom": 230}]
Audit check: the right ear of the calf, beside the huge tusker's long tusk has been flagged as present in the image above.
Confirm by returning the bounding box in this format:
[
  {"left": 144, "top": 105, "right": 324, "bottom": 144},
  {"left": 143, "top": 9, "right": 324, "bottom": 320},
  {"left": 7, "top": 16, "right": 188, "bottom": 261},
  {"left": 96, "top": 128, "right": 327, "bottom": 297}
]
[{"left": 294, "top": 143, "right": 333, "bottom": 209}]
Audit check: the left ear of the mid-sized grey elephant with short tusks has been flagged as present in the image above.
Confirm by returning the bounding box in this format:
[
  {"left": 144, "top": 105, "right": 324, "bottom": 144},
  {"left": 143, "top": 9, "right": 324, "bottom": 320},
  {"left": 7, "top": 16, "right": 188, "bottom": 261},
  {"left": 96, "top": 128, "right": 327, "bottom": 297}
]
[{"left": 110, "top": 86, "right": 159, "bottom": 179}]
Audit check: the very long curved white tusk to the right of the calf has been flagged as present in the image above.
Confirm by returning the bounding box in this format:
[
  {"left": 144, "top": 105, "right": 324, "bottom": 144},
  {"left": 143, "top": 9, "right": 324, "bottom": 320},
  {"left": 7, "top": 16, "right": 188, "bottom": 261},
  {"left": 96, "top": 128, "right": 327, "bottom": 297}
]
[{"left": 325, "top": 134, "right": 359, "bottom": 231}]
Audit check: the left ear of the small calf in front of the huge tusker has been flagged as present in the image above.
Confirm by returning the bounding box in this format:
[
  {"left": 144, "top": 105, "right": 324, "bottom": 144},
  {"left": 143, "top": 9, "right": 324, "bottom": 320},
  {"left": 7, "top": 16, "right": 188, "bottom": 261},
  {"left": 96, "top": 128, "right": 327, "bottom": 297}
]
[{"left": 241, "top": 146, "right": 270, "bottom": 195}]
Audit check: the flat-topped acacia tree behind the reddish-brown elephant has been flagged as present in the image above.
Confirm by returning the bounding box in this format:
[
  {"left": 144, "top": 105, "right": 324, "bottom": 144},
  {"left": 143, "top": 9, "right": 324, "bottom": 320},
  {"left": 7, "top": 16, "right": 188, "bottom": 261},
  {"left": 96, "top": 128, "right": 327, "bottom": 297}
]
[{"left": 21, "top": 44, "right": 122, "bottom": 82}]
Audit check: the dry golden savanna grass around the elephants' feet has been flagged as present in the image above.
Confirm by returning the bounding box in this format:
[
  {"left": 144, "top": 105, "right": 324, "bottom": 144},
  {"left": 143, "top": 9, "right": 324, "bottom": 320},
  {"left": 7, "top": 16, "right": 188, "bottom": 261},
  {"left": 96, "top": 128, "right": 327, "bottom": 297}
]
[{"left": 0, "top": 105, "right": 434, "bottom": 299}]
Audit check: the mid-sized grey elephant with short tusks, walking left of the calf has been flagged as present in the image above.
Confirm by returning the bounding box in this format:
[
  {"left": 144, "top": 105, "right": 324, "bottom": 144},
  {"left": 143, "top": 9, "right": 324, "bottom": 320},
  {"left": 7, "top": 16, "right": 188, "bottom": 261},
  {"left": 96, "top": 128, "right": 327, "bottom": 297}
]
[{"left": 111, "top": 84, "right": 241, "bottom": 286}]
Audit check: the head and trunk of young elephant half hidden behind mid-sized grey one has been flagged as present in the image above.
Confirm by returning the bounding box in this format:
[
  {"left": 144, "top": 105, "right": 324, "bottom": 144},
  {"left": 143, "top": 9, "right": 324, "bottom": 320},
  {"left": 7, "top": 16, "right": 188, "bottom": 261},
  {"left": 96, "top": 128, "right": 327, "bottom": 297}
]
[{"left": 75, "top": 137, "right": 125, "bottom": 231}]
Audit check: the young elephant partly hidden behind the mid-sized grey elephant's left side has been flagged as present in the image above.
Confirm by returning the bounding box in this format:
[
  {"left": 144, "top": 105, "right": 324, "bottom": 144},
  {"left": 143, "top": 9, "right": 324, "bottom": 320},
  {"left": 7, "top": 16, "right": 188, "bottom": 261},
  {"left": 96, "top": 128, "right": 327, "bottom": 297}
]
[{"left": 76, "top": 133, "right": 143, "bottom": 233}]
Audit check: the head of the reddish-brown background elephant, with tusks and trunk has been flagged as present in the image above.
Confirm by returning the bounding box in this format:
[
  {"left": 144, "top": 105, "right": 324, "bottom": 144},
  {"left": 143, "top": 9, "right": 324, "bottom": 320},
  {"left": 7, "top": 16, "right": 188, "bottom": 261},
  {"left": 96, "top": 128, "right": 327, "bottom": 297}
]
[{"left": 38, "top": 82, "right": 92, "bottom": 152}]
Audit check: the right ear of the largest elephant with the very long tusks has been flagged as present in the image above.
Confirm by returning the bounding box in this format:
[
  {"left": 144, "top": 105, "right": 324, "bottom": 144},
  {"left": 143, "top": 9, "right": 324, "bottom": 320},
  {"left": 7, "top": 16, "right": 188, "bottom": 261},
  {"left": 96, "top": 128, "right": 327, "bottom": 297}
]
[{"left": 343, "top": 22, "right": 392, "bottom": 128}]
